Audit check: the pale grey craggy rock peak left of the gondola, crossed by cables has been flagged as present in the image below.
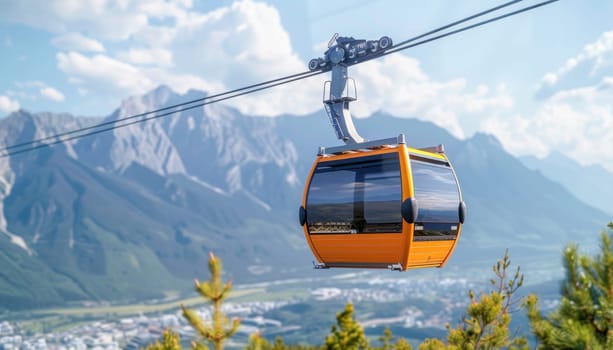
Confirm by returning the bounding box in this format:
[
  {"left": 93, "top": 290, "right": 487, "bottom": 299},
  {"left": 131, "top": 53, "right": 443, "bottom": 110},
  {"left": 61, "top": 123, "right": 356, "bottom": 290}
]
[{"left": 70, "top": 86, "right": 298, "bottom": 202}]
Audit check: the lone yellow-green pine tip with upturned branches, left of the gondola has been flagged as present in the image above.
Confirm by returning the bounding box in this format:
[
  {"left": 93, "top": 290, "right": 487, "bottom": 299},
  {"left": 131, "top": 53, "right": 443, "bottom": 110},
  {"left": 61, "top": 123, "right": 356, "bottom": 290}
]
[{"left": 181, "top": 253, "right": 240, "bottom": 350}]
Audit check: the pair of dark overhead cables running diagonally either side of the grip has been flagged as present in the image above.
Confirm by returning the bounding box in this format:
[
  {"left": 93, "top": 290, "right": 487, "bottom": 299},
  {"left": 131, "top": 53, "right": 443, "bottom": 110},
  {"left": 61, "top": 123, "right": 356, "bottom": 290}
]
[{"left": 0, "top": 0, "right": 559, "bottom": 158}]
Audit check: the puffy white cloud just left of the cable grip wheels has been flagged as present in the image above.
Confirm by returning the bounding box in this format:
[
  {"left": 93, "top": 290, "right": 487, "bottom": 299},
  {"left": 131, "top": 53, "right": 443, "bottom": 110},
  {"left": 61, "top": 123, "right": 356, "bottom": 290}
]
[{"left": 171, "top": 1, "right": 306, "bottom": 85}]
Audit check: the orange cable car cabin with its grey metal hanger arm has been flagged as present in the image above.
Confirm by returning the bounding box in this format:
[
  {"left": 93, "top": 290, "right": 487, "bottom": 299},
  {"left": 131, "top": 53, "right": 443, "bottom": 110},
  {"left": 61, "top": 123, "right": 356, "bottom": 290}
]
[{"left": 299, "top": 35, "right": 466, "bottom": 271}]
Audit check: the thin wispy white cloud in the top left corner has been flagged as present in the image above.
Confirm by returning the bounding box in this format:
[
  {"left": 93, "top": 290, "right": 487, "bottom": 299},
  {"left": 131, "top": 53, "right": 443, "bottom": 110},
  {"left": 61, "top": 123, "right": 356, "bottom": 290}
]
[{"left": 0, "top": 0, "right": 192, "bottom": 47}]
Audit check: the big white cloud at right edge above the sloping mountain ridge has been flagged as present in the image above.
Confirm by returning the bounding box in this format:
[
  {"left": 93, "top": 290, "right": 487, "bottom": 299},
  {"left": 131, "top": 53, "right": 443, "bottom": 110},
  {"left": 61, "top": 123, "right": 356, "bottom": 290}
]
[{"left": 481, "top": 32, "right": 613, "bottom": 171}]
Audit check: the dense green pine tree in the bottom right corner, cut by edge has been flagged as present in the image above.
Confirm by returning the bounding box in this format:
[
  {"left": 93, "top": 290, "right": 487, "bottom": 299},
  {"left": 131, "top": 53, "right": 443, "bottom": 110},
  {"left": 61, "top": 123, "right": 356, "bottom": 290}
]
[{"left": 526, "top": 223, "right": 613, "bottom": 349}]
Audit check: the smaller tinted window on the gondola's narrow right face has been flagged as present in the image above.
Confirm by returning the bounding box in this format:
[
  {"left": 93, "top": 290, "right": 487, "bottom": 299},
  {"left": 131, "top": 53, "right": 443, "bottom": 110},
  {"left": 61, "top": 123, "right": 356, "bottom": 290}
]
[{"left": 411, "top": 156, "right": 460, "bottom": 240}]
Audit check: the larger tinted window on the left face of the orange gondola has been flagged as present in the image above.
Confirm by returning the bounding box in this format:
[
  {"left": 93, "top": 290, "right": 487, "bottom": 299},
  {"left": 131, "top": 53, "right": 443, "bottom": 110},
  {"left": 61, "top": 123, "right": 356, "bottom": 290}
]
[{"left": 307, "top": 154, "right": 402, "bottom": 234}]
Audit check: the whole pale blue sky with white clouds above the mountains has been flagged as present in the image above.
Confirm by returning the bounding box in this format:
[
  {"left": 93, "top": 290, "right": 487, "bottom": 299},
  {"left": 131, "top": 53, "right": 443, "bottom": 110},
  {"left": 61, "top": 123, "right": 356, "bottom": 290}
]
[{"left": 0, "top": 0, "right": 613, "bottom": 170}]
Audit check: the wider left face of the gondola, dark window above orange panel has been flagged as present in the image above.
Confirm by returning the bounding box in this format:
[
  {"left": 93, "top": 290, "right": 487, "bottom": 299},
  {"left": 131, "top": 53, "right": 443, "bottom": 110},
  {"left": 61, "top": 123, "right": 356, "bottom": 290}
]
[{"left": 303, "top": 149, "right": 405, "bottom": 268}]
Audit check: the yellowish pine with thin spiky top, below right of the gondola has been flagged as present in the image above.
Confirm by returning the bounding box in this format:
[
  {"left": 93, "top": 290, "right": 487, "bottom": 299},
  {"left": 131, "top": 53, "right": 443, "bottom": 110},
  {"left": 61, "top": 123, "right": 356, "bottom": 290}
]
[{"left": 419, "top": 250, "right": 527, "bottom": 350}]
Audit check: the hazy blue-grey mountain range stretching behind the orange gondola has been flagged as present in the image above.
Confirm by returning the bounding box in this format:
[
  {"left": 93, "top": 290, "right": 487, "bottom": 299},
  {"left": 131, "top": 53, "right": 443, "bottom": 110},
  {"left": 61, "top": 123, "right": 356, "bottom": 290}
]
[{"left": 0, "top": 86, "right": 610, "bottom": 309}]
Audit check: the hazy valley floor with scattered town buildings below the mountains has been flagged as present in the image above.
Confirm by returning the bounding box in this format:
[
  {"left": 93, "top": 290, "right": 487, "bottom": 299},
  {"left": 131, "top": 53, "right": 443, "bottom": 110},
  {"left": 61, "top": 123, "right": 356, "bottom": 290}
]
[{"left": 0, "top": 253, "right": 562, "bottom": 349}]
